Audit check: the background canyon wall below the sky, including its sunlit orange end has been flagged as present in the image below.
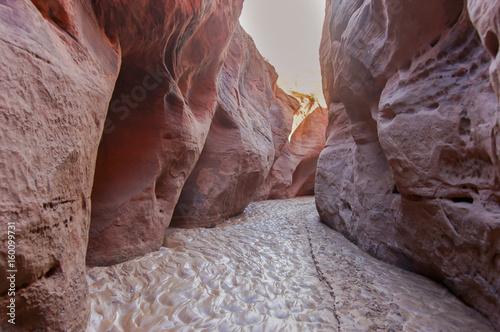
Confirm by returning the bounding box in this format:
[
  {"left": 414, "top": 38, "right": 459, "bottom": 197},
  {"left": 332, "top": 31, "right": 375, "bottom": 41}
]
[{"left": 170, "top": 27, "right": 328, "bottom": 228}]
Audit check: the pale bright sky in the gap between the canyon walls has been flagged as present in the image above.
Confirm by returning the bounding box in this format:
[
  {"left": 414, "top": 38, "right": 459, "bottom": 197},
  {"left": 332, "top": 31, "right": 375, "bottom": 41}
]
[{"left": 240, "top": 0, "right": 325, "bottom": 106}]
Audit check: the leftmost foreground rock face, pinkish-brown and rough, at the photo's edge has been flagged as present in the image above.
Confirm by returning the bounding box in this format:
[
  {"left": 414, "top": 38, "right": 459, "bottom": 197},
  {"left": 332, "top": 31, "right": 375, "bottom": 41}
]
[{"left": 0, "top": 0, "right": 120, "bottom": 331}]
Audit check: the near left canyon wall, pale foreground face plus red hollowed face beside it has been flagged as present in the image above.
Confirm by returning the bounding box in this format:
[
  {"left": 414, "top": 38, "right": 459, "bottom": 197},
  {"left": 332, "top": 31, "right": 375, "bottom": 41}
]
[{"left": 0, "top": 0, "right": 242, "bottom": 331}]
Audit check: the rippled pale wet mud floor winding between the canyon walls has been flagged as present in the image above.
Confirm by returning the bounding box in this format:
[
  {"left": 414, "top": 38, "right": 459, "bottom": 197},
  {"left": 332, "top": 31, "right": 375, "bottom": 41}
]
[{"left": 87, "top": 197, "right": 493, "bottom": 332}]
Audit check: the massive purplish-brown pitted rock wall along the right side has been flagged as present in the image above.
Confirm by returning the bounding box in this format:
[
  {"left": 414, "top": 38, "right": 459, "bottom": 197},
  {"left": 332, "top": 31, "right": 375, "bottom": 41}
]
[{"left": 316, "top": 0, "right": 500, "bottom": 328}]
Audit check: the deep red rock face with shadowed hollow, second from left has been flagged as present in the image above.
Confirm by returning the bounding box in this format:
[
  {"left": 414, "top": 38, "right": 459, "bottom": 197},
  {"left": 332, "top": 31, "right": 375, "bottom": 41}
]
[{"left": 87, "top": 0, "right": 242, "bottom": 265}]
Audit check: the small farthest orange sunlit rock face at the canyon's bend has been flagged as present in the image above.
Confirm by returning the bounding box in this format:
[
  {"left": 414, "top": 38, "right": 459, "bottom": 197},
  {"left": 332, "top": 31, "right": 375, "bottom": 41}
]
[{"left": 261, "top": 105, "right": 328, "bottom": 199}]
